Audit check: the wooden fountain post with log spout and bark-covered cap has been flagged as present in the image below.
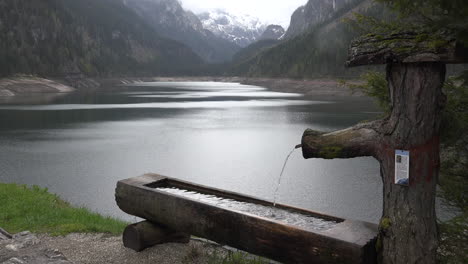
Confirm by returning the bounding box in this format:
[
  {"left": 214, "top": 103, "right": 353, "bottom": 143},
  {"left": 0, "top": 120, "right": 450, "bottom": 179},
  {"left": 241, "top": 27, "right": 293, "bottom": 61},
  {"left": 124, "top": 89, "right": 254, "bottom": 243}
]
[{"left": 302, "top": 33, "right": 468, "bottom": 264}]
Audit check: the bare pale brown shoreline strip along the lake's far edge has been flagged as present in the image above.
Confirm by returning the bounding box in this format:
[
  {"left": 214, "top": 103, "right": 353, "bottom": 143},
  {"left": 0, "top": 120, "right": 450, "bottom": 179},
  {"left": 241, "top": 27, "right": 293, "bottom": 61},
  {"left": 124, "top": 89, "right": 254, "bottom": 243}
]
[{"left": 0, "top": 76, "right": 362, "bottom": 101}]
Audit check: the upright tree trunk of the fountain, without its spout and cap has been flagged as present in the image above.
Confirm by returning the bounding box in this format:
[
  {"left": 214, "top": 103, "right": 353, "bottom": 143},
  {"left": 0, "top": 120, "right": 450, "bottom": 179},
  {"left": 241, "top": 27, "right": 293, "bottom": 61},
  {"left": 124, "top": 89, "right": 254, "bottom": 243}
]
[{"left": 376, "top": 62, "right": 445, "bottom": 264}]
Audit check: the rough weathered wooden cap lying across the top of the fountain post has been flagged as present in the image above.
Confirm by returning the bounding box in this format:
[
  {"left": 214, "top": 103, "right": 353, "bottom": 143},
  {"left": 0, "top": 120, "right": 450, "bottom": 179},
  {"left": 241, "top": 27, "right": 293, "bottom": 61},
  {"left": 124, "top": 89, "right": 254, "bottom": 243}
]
[{"left": 346, "top": 32, "right": 468, "bottom": 67}]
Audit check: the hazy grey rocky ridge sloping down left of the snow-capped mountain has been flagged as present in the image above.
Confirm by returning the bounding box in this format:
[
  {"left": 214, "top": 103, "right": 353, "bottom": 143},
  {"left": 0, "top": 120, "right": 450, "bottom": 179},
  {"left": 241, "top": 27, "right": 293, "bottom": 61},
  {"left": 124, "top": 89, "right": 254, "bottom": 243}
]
[{"left": 123, "top": 0, "right": 239, "bottom": 63}]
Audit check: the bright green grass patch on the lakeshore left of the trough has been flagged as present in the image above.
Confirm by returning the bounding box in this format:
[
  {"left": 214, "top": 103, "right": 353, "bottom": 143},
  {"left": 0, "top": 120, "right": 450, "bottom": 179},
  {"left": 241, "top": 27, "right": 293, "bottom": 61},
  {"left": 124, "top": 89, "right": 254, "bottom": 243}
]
[{"left": 0, "top": 183, "right": 127, "bottom": 235}]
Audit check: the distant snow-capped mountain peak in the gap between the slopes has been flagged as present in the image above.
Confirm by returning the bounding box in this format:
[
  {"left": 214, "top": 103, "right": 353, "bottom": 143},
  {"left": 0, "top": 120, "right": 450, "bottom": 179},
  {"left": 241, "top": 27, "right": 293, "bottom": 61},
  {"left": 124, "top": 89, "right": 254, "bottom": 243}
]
[{"left": 198, "top": 9, "right": 268, "bottom": 47}]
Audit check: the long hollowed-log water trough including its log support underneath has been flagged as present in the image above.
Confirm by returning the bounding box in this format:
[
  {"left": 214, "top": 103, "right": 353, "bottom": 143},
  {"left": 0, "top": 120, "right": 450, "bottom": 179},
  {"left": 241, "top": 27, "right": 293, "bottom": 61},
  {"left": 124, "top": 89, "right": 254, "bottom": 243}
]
[{"left": 115, "top": 174, "right": 377, "bottom": 263}]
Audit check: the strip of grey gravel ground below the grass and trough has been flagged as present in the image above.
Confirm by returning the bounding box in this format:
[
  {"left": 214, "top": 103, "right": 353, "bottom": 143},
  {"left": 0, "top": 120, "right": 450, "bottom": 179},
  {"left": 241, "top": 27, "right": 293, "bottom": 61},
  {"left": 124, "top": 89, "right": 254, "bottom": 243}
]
[{"left": 0, "top": 229, "right": 234, "bottom": 264}]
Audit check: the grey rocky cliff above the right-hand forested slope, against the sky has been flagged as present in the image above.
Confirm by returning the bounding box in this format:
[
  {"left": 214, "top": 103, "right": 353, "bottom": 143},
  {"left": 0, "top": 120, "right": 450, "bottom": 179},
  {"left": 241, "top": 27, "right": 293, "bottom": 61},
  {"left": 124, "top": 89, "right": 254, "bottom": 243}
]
[{"left": 285, "top": 0, "right": 362, "bottom": 38}]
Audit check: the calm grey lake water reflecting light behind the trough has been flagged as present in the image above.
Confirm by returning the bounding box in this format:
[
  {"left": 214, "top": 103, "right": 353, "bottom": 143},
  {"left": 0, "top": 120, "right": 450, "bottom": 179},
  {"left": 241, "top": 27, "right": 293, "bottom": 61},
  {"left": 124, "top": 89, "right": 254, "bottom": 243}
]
[{"left": 0, "top": 82, "right": 382, "bottom": 222}]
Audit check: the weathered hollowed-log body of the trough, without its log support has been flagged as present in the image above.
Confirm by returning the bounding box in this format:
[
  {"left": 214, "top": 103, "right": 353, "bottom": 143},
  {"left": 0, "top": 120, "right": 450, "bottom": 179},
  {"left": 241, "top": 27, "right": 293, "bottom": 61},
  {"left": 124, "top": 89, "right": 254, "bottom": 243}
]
[{"left": 116, "top": 174, "right": 377, "bottom": 263}]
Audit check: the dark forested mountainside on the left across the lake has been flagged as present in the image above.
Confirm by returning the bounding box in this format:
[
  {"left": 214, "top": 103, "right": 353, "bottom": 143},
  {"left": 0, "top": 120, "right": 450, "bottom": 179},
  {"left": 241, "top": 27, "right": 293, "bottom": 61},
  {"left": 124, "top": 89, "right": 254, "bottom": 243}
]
[{"left": 0, "top": 0, "right": 201, "bottom": 76}]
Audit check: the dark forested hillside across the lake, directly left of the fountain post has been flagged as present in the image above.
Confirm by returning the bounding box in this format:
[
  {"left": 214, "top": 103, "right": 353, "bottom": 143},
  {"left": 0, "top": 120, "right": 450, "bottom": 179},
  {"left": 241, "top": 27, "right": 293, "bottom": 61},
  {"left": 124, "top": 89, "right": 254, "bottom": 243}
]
[{"left": 229, "top": 0, "right": 390, "bottom": 78}]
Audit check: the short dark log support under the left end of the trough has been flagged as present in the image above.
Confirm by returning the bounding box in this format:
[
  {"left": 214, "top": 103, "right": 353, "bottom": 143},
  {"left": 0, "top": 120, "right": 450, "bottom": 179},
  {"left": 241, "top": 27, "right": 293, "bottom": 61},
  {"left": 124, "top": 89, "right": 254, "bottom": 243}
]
[{"left": 123, "top": 221, "right": 190, "bottom": 252}]
